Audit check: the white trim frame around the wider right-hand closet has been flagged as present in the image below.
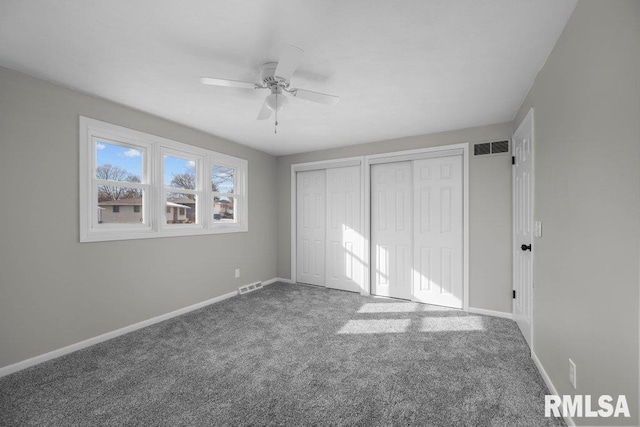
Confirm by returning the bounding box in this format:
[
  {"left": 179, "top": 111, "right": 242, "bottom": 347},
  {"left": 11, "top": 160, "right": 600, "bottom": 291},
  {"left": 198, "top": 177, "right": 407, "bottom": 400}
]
[{"left": 362, "top": 143, "right": 469, "bottom": 311}]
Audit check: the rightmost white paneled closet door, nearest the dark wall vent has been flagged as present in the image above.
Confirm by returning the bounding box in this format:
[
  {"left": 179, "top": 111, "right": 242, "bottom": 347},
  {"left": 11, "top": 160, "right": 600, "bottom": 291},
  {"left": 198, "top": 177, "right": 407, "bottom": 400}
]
[{"left": 413, "top": 156, "right": 463, "bottom": 308}]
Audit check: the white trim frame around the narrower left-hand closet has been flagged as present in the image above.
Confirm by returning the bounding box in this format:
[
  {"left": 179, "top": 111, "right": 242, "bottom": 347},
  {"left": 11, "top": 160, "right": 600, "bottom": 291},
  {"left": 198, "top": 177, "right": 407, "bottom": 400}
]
[{"left": 291, "top": 156, "right": 369, "bottom": 295}]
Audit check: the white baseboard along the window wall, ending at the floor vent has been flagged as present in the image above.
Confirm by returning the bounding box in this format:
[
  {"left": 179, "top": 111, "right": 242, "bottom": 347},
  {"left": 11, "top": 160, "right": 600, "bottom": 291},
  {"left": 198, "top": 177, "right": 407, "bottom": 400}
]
[{"left": 0, "top": 291, "right": 238, "bottom": 378}]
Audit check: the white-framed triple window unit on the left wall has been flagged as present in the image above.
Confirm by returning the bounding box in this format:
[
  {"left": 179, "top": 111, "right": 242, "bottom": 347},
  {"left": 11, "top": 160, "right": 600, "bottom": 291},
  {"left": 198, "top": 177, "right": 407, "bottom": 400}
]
[{"left": 80, "top": 117, "right": 248, "bottom": 242}]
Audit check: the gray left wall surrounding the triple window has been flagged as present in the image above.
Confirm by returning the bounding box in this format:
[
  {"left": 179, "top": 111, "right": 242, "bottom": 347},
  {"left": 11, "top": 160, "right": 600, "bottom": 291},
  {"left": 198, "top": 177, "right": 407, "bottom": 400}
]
[{"left": 0, "top": 68, "right": 277, "bottom": 367}]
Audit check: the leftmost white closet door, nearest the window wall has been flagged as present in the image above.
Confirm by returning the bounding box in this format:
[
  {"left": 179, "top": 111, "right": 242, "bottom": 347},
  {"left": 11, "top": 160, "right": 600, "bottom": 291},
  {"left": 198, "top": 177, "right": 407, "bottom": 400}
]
[{"left": 296, "top": 170, "right": 326, "bottom": 286}]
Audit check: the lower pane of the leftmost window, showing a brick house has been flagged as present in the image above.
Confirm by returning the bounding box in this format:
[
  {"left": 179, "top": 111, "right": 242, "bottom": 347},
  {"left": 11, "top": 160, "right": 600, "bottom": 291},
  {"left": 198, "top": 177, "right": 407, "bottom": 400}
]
[{"left": 98, "top": 185, "right": 144, "bottom": 224}]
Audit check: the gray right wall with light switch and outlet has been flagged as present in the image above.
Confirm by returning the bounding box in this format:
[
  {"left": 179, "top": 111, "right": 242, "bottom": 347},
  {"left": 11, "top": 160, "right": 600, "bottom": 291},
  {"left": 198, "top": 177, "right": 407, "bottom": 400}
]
[{"left": 514, "top": 0, "right": 640, "bottom": 425}]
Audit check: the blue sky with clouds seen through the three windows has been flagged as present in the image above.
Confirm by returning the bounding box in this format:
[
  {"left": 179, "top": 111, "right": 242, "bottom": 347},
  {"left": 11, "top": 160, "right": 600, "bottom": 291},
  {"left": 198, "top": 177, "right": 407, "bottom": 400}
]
[{"left": 96, "top": 141, "right": 234, "bottom": 193}]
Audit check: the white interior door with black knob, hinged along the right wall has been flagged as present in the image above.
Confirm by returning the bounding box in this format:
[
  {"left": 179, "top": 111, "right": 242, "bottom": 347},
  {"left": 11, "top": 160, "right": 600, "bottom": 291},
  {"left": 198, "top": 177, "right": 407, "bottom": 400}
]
[{"left": 513, "top": 111, "right": 533, "bottom": 347}]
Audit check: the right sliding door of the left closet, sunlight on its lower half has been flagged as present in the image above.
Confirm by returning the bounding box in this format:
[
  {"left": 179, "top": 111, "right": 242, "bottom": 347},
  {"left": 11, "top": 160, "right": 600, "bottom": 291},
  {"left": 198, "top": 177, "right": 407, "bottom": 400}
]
[{"left": 326, "top": 166, "right": 364, "bottom": 292}]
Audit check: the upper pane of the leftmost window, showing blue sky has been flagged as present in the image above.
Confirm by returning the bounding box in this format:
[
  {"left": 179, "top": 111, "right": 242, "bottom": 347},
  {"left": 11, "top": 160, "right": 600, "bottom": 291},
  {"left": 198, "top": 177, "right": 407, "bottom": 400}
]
[{"left": 95, "top": 141, "right": 142, "bottom": 182}]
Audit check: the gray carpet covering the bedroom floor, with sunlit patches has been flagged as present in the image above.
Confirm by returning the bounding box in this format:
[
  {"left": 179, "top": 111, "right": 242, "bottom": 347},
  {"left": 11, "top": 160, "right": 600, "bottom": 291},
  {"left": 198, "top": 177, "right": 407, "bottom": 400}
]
[{"left": 0, "top": 283, "right": 564, "bottom": 426}]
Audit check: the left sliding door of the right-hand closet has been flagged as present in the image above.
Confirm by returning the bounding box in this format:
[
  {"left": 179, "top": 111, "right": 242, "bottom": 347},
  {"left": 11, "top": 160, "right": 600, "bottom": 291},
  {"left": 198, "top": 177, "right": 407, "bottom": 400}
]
[{"left": 371, "top": 162, "right": 413, "bottom": 299}]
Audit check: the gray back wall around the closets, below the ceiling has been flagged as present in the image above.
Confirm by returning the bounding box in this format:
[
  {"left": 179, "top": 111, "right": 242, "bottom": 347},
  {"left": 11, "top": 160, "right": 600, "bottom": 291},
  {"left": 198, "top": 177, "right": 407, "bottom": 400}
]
[{"left": 278, "top": 123, "right": 512, "bottom": 313}]
